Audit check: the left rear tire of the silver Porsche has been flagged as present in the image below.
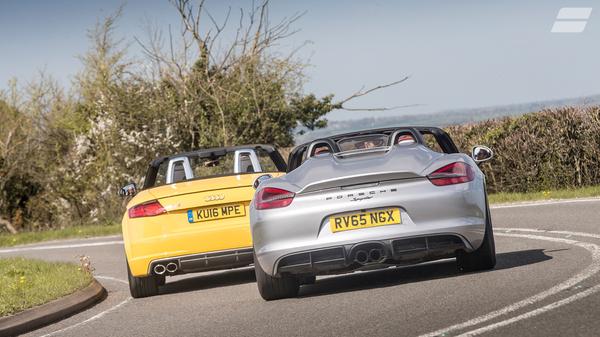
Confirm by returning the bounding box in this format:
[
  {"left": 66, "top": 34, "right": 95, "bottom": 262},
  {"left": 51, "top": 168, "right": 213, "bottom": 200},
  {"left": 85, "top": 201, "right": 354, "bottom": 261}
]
[{"left": 254, "top": 251, "right": 300, "bottom": 301}]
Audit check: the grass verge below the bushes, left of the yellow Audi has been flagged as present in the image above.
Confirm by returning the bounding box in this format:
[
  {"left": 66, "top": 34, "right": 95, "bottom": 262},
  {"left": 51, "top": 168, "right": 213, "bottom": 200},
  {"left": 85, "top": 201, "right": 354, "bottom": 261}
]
[{"left": 0, "top": 224, "right": 121, "bottom": 247}]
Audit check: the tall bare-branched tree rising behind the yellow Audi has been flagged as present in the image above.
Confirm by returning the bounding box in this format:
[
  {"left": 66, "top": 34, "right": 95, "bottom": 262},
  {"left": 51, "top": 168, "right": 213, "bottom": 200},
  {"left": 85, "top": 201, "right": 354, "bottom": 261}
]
[{"left": 138, "top": 0, "right": 413, "bottom": 145}]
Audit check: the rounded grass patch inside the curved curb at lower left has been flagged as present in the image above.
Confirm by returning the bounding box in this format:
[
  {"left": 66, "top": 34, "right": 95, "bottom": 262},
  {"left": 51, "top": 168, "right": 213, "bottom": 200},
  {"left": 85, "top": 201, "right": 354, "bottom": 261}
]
[{"left": 0, "top": 257, "right": 92, "bottom": 317}]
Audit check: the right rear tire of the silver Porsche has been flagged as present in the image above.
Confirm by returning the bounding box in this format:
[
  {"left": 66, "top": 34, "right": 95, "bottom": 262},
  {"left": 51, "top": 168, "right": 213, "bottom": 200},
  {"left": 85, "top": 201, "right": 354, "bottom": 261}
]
[{"left": 456, "top": 195, "right": 496, "bottom": 272}]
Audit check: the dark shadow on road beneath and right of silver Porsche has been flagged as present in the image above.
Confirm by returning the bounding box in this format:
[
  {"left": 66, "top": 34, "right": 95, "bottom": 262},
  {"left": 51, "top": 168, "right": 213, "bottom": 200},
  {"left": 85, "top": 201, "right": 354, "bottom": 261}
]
[{"left": 300, "top": 249, "right": 552, "bottom": 297}]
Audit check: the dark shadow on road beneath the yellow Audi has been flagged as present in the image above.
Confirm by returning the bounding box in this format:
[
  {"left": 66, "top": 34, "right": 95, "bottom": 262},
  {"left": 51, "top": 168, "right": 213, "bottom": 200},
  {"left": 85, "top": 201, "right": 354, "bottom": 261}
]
[{"left": 160, "top": 268, "right": 256, "bottom": 294}]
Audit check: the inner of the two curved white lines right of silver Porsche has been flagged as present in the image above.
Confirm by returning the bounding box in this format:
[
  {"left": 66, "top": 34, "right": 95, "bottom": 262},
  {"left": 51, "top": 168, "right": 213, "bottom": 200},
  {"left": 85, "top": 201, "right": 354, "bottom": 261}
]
[{"left": 420, "top": 228, "right": 600, "bottom": 337}]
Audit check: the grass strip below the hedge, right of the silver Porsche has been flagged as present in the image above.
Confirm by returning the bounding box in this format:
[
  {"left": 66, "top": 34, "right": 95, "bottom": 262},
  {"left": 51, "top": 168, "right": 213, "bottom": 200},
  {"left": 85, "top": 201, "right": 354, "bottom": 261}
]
[{"left": 488, "top": 186, "right": 600, "bottom": 204}]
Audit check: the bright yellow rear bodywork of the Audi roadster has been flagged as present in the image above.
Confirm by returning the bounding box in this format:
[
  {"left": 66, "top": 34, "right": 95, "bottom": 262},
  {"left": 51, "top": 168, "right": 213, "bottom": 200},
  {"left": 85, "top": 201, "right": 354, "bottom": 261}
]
[{"left": 122, "top": 172, "right": 283, "bottom": 277}]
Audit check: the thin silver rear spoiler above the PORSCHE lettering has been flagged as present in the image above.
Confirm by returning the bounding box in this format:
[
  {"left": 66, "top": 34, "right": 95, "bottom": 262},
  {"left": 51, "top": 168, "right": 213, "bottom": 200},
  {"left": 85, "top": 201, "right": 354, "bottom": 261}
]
[{"left": 297, "top": 172, "right": 424, "bottom": 194}]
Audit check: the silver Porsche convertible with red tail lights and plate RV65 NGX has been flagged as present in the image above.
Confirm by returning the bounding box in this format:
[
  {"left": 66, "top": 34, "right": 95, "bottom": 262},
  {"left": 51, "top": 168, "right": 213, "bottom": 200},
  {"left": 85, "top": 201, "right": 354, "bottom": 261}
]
[{"left": 250, "top": 127, "right": 496, "bottom": 300}]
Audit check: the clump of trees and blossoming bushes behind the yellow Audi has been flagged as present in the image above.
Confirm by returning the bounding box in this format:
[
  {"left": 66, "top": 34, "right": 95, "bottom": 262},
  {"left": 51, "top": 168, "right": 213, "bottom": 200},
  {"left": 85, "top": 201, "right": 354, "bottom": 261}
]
[{"left": 0, "top": 0, "right": 408, "bottom": 232}]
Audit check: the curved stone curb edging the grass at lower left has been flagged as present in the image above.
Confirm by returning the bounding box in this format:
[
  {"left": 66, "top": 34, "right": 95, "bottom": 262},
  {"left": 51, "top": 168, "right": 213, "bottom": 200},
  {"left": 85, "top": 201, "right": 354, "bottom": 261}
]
[{"left": 0, "top": 279, "right": 106, "bottom": 336}]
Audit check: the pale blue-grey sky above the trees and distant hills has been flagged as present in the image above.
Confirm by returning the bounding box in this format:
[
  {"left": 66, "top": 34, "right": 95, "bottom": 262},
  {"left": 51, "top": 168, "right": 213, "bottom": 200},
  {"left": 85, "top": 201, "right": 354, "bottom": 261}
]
[{"left": 0, "top": 0, "right": 600, "bottom": 120}]
